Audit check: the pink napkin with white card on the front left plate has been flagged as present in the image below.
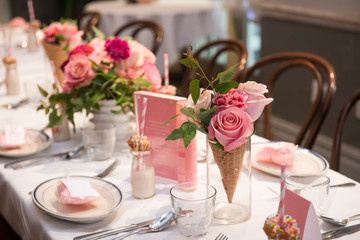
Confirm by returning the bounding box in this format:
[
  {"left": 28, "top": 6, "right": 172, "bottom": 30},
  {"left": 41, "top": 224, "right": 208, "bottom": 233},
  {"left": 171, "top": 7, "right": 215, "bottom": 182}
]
[{"left": 55, "top": 179, "right": 100, "bottom": 205}]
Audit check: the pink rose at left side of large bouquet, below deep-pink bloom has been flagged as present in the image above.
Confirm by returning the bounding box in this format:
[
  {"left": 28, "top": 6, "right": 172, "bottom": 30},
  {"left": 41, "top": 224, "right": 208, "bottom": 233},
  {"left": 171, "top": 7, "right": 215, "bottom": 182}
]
[{"left": 63, "top": 54, "right": 95, "bottom": 93}]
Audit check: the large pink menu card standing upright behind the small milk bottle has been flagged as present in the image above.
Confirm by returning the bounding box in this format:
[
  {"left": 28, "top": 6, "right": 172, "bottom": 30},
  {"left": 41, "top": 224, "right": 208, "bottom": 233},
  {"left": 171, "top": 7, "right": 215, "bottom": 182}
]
[{"left": 134, "top": 91, "right": 197, "bottom": 183}]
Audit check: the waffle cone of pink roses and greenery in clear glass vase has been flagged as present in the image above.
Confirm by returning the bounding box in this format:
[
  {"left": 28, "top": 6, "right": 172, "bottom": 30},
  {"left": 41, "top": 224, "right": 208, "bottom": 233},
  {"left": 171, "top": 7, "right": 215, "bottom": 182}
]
[{"left": 166, "top": 51, "right": 273, "bottom": 223}]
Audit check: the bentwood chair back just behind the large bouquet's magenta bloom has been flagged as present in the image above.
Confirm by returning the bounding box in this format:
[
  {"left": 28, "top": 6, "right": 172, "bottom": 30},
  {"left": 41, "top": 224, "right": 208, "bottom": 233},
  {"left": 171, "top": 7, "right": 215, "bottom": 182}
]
[{"left": 113, "top": 19, "right": 164, "bottom": 55}]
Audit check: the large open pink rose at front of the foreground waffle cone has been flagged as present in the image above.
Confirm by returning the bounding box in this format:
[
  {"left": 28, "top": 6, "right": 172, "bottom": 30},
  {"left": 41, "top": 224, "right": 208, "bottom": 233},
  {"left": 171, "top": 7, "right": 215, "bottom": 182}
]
[{"left": 208, "top": 106, "right": 254, "bottom": 152}]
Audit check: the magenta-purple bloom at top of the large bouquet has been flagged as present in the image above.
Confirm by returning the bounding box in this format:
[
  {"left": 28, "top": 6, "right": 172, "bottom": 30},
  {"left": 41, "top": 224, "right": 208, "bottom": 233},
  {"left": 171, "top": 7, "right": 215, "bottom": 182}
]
[{"left": 105, "top": 37, "right": 130, "bottom": 61}]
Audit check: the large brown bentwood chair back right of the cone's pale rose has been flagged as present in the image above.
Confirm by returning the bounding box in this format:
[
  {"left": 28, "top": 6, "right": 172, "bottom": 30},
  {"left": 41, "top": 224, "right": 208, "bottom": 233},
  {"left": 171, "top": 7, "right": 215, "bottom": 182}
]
[{"left": 239, "top": 52, "right": 336, "bottom": 149}]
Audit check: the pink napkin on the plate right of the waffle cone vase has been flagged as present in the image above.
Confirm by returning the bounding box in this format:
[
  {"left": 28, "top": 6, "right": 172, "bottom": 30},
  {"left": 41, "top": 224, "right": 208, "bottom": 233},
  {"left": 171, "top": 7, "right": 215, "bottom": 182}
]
[{"left": 256, "top": 142, "right": 295, "bottom": 167}]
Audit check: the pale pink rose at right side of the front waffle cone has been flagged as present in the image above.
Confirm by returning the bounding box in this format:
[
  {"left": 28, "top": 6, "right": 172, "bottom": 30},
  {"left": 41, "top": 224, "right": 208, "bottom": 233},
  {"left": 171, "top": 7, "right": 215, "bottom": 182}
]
[{"left": 238, "top": 81, "right": 274, "bottom": 121}]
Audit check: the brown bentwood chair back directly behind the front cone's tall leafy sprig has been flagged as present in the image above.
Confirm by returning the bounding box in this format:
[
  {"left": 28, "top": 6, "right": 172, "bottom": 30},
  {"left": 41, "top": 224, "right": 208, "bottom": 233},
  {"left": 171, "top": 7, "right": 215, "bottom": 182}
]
[{"left": 181, "top": 39, "right": 248, "bottom": 96}]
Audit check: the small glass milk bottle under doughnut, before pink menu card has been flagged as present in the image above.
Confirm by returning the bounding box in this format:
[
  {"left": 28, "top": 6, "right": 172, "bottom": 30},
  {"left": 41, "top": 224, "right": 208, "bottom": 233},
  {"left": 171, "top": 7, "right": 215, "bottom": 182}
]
[{"left": 131, "top": 151, "right": 155, "bottom": 199}]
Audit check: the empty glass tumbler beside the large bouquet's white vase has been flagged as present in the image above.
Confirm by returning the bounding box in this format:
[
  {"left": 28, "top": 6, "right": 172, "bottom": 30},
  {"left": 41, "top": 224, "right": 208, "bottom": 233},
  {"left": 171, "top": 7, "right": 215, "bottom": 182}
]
[{"left": 82, "top": 123, "right": 116, "bottom": 160}]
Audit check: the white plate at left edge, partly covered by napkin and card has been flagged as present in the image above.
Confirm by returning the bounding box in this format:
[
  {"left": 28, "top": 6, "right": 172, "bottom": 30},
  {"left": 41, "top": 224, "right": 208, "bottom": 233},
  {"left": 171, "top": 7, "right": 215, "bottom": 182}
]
[{"left": 0, "top": 129, "right": 51, "bottom": 158}]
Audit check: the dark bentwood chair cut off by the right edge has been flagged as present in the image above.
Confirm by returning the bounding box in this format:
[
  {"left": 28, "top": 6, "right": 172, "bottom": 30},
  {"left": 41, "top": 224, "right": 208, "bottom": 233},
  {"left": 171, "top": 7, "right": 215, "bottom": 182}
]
[{"left": 330, "top": 89, "right": 360, "bottom": 171}]
